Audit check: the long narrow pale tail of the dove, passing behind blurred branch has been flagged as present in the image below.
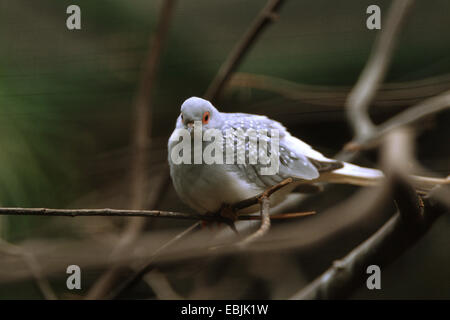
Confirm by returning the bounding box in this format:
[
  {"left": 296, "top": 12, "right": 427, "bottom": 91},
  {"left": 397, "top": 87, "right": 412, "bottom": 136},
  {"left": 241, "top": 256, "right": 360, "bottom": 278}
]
[{"left": 320, "top": 162, "right": 450, "bottom": 193}]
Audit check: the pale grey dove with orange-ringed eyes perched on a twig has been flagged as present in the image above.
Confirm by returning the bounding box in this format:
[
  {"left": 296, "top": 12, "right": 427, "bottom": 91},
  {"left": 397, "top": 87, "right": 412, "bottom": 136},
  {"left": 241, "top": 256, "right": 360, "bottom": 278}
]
[{"left": 168, "top": 97, "right": 446, "bottom": 213}]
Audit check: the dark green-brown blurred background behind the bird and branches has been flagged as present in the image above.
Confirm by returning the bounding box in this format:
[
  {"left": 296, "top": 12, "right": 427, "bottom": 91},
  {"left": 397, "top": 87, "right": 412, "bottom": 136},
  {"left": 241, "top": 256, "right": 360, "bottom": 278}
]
[{"left": 0, "top": 0, "right": 450, "bottom": 299}]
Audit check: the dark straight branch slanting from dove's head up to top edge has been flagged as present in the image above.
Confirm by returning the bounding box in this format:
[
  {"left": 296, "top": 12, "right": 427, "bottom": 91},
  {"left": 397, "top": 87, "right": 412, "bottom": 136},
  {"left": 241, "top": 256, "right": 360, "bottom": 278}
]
[{"left": 204, "top": 0, "right": 284, "bottom": 101}]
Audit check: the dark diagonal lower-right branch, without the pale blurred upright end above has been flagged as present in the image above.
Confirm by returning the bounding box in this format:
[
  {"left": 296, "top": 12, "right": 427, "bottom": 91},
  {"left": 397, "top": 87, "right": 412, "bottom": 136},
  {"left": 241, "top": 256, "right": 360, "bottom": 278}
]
[{"left": 291, "top": 180, "right": 445, "bottom": 299}]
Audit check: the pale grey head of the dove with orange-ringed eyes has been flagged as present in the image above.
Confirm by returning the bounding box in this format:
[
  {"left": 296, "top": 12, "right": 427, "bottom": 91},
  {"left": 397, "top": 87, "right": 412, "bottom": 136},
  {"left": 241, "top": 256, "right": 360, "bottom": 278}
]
[{"left": 177, "top": 97, "right": 222, "bottom": 131}]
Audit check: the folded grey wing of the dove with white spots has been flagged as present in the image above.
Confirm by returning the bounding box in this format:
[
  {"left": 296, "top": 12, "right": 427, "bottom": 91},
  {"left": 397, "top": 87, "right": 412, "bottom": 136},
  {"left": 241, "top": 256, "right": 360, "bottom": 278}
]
[{"left": 222, "top": 113, "right": 319, "bottom": 187}]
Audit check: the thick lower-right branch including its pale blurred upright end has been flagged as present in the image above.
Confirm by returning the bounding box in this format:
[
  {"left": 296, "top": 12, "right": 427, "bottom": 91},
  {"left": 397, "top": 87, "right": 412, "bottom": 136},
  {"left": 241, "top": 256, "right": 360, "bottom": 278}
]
[{"left": 292, "top": 131, "right": 448, "bottom": 299}]
